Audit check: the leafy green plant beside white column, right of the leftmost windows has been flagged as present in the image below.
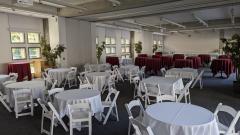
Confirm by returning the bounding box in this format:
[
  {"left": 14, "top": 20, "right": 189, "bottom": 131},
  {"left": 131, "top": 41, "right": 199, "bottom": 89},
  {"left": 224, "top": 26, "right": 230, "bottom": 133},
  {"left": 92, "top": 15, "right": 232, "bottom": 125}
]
[{"left": 40, "top": 37, "right": 66, "bottom": 67}]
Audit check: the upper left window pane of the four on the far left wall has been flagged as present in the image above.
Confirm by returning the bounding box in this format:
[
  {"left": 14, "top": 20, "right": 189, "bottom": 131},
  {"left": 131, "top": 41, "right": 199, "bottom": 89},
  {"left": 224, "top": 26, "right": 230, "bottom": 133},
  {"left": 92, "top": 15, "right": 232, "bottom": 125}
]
[{"left": 10, "top": 32, "right": 25, "bottom": 44}]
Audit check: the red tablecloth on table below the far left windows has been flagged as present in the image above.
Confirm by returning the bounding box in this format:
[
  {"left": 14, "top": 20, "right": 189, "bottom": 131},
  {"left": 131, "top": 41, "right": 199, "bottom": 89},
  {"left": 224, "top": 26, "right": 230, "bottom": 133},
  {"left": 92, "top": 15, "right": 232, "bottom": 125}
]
[{"left": 8, "top": 62, "right": 32, "bottom": 81}]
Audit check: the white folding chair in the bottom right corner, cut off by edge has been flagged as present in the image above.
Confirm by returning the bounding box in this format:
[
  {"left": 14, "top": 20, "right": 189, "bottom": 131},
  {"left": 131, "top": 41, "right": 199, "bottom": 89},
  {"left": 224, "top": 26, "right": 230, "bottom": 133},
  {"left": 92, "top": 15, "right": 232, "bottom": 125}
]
[{"left": 214, "top": 103, "right": 240, "bottom": 135}]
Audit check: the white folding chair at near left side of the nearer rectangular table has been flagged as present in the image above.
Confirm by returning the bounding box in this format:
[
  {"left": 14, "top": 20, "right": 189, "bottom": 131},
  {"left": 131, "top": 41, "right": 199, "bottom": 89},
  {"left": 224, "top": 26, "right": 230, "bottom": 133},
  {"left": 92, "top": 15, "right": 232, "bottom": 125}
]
[{"left": 143, "top": 83, "right": 161, "bottom": 107}]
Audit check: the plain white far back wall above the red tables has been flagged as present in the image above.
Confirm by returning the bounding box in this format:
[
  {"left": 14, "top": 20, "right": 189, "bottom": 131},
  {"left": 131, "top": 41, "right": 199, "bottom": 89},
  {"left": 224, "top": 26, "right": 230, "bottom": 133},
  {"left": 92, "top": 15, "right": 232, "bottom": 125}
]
[{"left": 164, "top": 30, "right": 220, "bottom": 54}]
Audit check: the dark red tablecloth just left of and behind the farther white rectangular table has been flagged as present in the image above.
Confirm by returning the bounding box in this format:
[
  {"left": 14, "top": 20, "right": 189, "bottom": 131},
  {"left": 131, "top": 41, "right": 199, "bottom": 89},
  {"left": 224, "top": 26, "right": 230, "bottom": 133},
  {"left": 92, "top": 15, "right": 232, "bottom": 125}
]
[{"left": 146, "top": 58, "right": 162, "bottom": 73}]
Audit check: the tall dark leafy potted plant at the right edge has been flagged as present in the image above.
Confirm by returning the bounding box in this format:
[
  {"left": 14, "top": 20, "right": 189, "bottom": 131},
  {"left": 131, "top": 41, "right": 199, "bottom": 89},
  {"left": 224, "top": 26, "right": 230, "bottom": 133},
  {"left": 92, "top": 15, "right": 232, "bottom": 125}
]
[{"left": 221, "top": 34, "right": 240, "bottom": 89}]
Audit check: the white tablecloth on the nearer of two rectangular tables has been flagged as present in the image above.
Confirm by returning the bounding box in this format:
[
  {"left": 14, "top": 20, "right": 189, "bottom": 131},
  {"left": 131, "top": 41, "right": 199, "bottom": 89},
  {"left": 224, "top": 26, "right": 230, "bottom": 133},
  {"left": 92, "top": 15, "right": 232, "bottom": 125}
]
[{"left": 140, "top": 76, "right": 184, "bottom": 95}]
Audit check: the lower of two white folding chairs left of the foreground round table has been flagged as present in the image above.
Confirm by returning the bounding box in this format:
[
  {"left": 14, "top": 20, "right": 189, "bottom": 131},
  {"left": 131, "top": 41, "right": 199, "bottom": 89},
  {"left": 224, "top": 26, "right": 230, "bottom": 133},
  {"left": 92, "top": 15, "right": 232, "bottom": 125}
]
[{"left": 129, "top": 117, "right": 154, "bottom": 135}]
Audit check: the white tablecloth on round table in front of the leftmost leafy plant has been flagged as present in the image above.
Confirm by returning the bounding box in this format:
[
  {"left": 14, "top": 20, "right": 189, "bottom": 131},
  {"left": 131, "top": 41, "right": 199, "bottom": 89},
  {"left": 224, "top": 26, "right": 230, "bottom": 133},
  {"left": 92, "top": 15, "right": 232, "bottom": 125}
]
[{"left": 48, "top": 68, "right": 71, "bottom": 86}]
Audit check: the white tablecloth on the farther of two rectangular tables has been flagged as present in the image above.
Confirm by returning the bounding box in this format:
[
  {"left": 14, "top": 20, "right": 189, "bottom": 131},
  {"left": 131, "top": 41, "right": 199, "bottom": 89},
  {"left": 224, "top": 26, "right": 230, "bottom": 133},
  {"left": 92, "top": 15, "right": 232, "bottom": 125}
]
[{"left": 166, "top": 68, "right": 198, "bottom": 78}]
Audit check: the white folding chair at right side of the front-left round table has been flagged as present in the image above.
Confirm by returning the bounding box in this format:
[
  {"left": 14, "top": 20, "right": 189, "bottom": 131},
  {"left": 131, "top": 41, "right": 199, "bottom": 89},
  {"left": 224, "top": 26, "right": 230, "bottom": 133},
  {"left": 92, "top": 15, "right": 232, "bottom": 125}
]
[{"left": 102, "top": 89, "right": 120, "bottom": 125}]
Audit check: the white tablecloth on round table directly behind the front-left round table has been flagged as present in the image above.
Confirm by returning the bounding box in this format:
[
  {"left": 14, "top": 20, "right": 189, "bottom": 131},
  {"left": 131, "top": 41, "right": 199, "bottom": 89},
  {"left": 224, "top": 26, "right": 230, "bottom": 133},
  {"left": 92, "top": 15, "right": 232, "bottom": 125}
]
[{"left": 86, "top": 72, "right": 110, "bottom": 91}]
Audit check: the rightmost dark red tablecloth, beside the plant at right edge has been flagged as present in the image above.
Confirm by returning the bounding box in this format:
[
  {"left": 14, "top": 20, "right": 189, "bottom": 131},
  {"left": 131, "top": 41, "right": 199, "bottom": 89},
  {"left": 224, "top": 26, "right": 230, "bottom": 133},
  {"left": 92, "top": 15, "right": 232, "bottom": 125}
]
[{"left": 210, "top": 59, "right": 233, "bottom": 77}]
